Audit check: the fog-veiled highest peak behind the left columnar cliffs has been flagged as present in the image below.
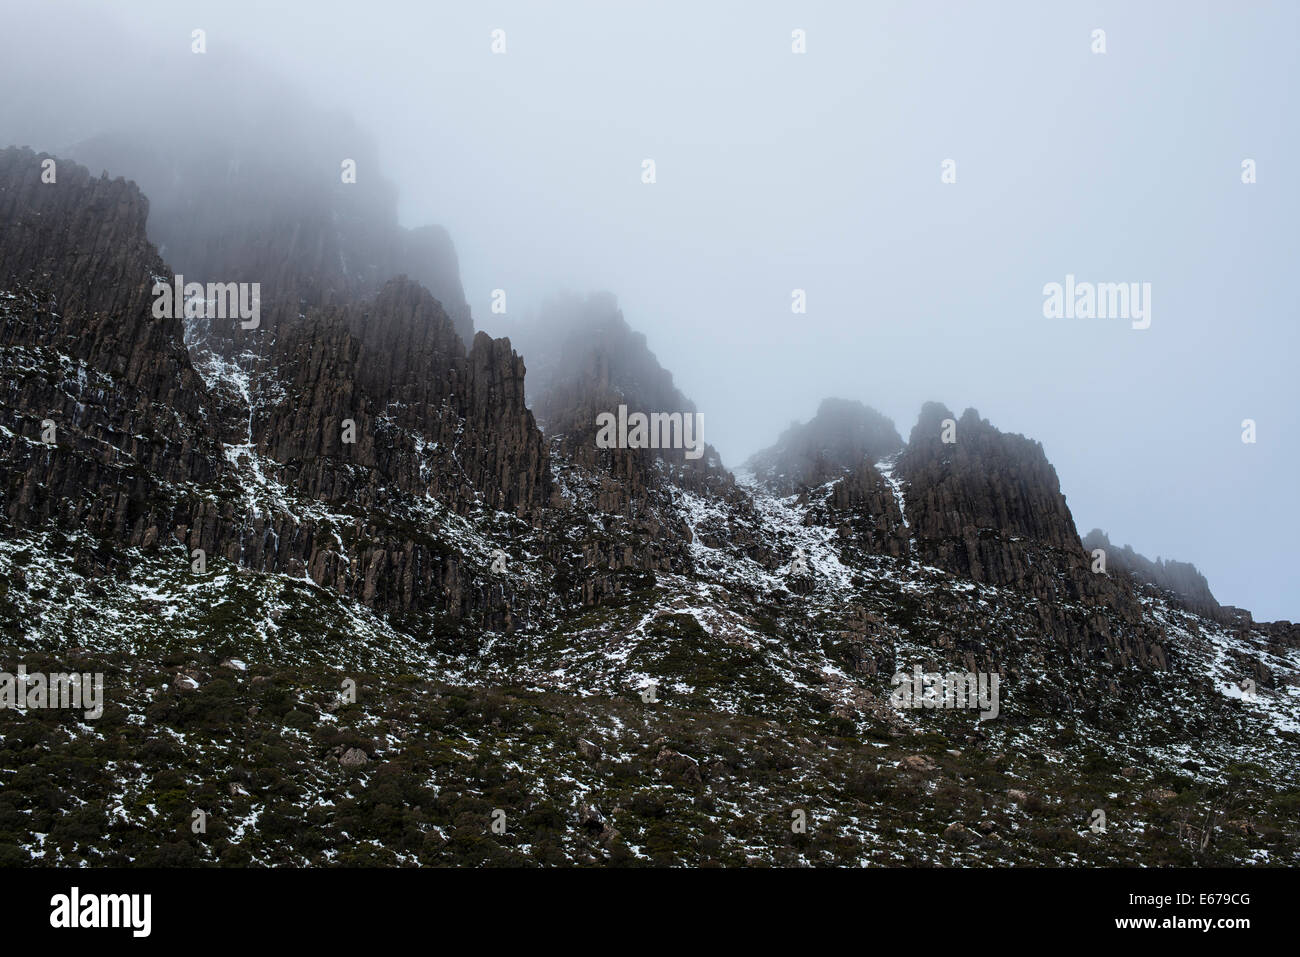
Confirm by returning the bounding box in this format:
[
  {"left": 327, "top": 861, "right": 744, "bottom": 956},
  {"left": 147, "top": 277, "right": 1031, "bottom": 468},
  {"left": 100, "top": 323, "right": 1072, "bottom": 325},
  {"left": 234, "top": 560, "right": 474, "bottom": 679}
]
[{"left": 72, "top": 120, "right": 475, "bottom": 355}]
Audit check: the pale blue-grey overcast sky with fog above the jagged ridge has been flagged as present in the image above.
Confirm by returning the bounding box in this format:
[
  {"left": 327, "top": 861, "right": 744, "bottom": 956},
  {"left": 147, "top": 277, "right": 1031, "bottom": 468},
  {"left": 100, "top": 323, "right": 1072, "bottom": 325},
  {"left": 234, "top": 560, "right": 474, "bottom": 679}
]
[{"left": 0, "top": 0, "right": 1300, "bottom": 620}]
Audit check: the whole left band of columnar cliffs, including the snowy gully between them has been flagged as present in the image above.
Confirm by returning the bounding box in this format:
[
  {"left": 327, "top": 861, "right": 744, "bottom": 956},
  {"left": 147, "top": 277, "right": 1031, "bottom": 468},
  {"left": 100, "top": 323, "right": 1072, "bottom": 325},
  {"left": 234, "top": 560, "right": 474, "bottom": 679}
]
[{"left": 0, "top": 150, "right": 550, "bottom": 627}]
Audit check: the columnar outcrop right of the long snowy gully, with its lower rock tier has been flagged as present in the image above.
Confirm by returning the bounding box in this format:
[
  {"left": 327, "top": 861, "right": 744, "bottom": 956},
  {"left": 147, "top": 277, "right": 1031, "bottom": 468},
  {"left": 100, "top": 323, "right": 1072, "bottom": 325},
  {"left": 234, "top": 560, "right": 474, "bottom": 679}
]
[{"left": 177, "top": 278, "right": 550, "bottom": 631}]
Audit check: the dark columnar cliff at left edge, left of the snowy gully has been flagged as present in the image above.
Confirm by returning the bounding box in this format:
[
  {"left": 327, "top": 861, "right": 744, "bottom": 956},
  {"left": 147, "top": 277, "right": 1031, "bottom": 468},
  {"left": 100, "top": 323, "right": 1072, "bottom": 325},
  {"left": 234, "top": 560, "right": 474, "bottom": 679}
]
[{"left": 0, "top": 148, "right": 222, "bottom": 556}]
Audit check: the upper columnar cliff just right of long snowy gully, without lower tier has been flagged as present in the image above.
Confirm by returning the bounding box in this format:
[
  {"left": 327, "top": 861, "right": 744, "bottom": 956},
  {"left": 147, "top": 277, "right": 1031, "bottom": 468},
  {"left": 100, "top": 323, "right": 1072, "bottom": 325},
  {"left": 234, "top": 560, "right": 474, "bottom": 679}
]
[{"left": 241, "top": 280, "right": 549, "bottom": 514}]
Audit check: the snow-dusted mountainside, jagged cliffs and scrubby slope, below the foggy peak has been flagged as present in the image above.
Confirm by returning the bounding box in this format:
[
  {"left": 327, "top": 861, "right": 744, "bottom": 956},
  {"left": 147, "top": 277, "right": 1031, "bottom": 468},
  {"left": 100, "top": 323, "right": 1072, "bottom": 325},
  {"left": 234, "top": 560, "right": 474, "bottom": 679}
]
[{"left": 0, "top": 148, "right": 1300, "bottom": 866}]
